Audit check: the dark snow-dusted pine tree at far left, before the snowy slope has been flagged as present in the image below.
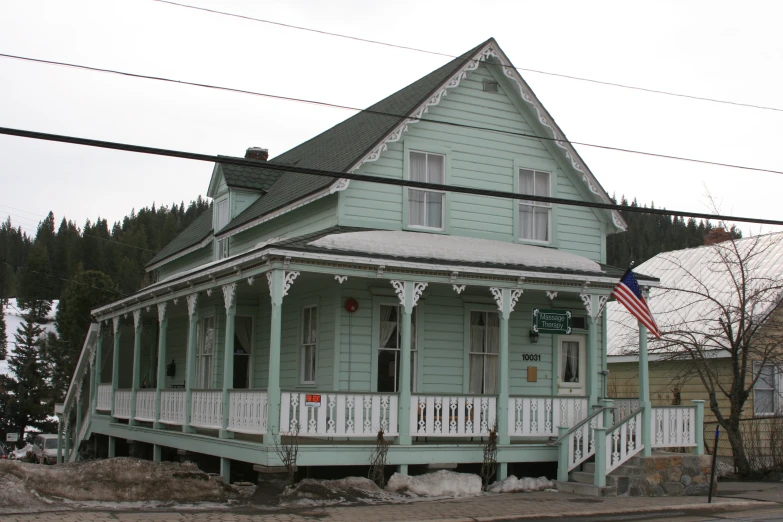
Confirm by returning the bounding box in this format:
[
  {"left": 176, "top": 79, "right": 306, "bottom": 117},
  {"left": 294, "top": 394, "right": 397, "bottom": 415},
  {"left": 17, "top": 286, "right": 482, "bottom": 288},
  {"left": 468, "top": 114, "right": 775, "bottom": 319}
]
[{"left": 8, "top": 305, "right": 52, "bottom": 440}]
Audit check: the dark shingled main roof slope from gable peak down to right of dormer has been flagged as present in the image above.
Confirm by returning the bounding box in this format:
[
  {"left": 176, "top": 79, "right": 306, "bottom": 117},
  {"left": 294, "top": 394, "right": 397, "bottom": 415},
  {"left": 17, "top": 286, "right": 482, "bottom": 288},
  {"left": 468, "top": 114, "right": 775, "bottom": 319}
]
[{"left": 221, "top": 40, "right": 492, "bottom": 232}]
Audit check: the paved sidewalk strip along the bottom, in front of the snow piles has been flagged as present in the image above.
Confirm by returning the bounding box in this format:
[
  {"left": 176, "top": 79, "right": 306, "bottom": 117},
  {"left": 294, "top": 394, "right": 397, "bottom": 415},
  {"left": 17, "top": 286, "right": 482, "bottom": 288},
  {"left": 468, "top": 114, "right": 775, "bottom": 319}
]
[{"left": 0, "top": 490, "right": 772, "bottom": 522}]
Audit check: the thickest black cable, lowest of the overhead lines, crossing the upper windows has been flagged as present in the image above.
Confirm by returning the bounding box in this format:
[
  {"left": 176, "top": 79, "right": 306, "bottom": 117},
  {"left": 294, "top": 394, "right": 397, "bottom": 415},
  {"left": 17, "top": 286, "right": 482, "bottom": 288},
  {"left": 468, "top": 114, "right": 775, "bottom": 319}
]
[{"left": 0, "top": 127, "right": 783, "bottom": 225}]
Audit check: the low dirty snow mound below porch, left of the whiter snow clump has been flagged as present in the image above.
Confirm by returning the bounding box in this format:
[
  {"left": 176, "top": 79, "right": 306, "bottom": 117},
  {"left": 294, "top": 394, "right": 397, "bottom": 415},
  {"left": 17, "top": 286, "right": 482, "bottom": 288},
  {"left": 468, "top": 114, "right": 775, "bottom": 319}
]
[{"left": 281, "top": 477, "right": 401, "bottom": 506}]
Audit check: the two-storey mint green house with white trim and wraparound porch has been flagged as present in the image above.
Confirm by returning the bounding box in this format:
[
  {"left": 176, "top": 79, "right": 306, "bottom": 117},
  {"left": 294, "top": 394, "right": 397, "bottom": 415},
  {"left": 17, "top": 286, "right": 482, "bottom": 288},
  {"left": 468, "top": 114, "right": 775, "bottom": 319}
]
[{"left": 57, "top": 39, "right": 698, "bottom": 490}]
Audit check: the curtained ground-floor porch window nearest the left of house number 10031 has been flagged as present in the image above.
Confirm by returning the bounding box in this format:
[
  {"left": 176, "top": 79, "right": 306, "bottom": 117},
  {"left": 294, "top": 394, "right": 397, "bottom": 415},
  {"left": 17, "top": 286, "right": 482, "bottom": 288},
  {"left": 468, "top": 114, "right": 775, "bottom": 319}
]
[{"left": 469, "top": 312, "right": 500, "bottom": 395}]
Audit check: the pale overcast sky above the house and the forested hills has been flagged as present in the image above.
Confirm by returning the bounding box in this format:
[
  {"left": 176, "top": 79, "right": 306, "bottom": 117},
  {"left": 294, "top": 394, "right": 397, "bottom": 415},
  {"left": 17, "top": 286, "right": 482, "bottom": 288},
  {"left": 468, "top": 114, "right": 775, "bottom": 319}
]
[{"left": 0, "top": 0, "right": 783, "bottom": 238}]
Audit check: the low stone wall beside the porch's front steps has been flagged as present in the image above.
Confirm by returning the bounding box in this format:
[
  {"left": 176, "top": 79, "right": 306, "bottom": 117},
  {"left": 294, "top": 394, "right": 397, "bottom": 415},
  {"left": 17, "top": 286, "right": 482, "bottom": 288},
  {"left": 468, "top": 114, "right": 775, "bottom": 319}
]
[{"left": 612, "top": 452, "right": 717, "bottom": 497}]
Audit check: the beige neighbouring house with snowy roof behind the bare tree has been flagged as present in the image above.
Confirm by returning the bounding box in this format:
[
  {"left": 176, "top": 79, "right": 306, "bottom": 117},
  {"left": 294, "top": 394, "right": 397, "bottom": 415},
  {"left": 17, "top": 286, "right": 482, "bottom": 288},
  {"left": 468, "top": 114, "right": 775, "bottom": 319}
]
[{"left": 607, "top": 229, "right": 783, "bottom": 430}]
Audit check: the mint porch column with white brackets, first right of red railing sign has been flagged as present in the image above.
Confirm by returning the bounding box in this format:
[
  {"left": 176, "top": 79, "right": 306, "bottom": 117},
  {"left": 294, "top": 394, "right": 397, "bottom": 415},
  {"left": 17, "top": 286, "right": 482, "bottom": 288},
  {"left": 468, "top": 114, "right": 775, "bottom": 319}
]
[{"left": 391, "top": 281, "right": 427, "bottom": 445}]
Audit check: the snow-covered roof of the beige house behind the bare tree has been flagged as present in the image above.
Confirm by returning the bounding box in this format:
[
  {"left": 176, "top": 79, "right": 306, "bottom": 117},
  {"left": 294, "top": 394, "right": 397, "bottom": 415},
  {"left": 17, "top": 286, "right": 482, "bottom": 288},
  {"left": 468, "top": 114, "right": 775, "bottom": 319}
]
[{"left": 606, "top": 232, "right": 783, "bottom": 356}]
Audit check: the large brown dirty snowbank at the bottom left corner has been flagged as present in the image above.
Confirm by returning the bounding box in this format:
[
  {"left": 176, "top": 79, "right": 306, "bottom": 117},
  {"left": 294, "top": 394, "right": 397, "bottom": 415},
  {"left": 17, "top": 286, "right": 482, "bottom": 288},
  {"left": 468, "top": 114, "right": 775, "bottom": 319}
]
[{"left": 0, "top": 458, "right": 232, "bottom": 506}]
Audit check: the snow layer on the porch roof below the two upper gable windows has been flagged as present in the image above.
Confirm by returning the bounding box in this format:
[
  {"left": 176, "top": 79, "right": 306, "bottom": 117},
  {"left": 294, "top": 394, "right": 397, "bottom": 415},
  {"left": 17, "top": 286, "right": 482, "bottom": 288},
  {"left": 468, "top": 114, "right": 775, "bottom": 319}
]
[{"left": 309, "top": 230, "right": 602, "bottom": 272}]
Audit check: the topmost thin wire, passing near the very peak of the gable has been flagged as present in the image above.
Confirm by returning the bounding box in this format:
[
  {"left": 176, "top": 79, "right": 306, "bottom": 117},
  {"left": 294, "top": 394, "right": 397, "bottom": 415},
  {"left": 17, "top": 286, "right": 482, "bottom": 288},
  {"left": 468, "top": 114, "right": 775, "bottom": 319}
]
[{"left": 153, "top": 0, "right": 783, "bottom": 112}]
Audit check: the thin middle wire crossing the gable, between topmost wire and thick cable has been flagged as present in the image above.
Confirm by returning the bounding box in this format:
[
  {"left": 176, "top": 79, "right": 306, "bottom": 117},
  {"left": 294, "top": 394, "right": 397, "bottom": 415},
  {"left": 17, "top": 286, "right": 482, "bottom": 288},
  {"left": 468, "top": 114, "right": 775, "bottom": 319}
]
[{"left": 0, "top": 53, "right": 783, "bottom": 174}]
